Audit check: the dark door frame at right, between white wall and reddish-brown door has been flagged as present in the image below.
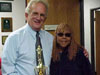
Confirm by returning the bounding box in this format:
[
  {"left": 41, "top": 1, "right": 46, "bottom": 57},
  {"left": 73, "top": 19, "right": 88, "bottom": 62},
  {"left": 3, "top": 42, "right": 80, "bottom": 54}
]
[{"left": 90, "top": 7, "right": 100, "bottom": 74}]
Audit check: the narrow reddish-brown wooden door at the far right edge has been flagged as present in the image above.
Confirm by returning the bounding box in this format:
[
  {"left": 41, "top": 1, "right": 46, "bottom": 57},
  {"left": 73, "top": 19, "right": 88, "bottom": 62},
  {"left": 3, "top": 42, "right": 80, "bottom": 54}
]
[{"left": 96, "top": 11, "right": 100, "bottom": 75}]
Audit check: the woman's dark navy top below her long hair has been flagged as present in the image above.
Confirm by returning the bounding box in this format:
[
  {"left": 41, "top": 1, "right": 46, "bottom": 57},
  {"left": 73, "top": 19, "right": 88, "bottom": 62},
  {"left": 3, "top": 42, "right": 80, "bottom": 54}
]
[{"left": 50, "top": 50, "right": 94, "bottom": 75}]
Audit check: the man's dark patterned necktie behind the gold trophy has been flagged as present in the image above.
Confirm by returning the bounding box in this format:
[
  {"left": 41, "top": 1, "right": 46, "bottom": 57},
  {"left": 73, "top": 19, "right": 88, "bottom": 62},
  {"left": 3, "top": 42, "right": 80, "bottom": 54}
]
[{"left": 36, "top": 31, "right": 44, "bottom": 65}]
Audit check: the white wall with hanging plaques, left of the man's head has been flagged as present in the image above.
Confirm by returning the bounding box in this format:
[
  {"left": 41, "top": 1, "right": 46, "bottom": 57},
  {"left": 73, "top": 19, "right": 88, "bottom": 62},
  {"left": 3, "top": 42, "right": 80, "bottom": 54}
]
[{"left": 0, "top": 0, "right": 25, "bottom": 57}]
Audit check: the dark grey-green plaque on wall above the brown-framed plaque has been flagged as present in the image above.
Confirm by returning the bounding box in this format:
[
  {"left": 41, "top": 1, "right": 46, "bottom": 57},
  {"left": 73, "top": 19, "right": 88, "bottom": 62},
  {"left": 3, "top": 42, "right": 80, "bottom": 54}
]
[{"left": 0, "top": 2, "right": 12, "bottom": 12}]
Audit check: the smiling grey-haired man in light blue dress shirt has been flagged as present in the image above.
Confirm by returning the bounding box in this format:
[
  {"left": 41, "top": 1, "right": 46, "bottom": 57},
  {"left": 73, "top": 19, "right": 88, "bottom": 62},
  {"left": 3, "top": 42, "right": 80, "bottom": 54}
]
[{"left": 2, "top": 0, "right": 53, "bottom": 75}]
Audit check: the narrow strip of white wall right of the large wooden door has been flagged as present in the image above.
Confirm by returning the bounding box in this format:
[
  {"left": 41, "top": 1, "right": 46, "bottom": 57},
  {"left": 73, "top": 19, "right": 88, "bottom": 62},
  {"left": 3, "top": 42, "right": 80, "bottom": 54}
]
[{"left": 84, "top": 0, "right": 100, "bottom": 59}]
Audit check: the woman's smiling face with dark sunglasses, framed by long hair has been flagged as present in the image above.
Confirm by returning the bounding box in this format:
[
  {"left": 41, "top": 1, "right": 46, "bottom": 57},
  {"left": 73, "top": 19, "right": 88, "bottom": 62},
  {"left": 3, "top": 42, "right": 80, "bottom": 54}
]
[{"left": 57, "top": 31, "right": 71, "bottom": 48}]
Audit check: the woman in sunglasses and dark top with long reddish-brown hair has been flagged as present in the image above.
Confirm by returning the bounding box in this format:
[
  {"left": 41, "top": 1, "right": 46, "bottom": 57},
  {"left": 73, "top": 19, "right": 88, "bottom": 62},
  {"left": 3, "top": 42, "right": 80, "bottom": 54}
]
[{"left": 50, "top": 24, "right": 94, "bottom": 75}]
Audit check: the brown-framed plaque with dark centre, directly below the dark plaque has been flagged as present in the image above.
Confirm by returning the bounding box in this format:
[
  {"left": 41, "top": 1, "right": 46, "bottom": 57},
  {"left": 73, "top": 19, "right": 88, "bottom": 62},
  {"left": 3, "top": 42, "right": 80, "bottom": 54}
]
[{"left": 1, "top": 17, "right": 12, "bottom": 32}]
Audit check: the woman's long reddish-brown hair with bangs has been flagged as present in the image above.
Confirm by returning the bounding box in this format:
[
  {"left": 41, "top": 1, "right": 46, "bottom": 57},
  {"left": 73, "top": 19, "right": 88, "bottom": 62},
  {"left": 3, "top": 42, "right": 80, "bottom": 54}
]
[{"left": 52, "top": 23, "right": 81, "bottom": 61}]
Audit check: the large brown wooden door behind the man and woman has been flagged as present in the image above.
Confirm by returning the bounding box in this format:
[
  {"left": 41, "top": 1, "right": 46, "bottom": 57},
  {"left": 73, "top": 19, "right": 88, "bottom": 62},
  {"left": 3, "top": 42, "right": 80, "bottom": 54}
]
[{"left": 44, "top": 0, "right": 80, "bottom": 43}]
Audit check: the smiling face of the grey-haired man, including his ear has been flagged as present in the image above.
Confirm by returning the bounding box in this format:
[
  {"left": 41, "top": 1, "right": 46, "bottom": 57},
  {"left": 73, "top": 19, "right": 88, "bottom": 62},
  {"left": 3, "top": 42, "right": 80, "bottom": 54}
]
[{"left": 25, "top": 3, "right": 46, "bottom": 31}]
